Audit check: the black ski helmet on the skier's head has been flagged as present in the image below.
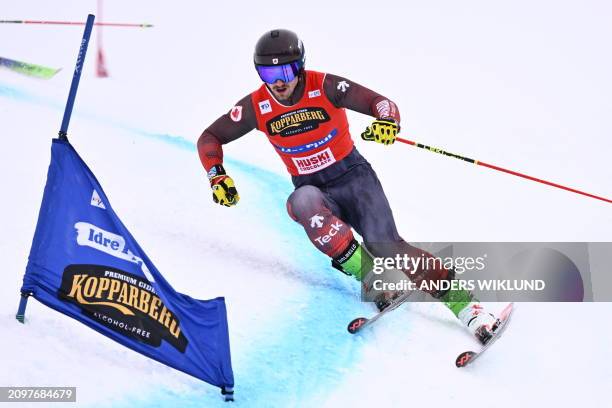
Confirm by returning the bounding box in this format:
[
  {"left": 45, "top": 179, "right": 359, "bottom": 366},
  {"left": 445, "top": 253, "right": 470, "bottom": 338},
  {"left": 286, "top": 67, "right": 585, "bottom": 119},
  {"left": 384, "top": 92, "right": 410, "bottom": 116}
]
[{"left": 253, "top": 29, "right": 306, "bottom": 67}]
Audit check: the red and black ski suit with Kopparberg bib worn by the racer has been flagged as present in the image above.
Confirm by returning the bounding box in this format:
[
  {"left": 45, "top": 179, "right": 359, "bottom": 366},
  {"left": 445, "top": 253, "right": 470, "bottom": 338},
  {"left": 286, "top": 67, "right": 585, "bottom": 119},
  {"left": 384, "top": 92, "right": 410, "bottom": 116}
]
[{"left": 198, "top": 71, "right": 447, "bottom": 294}]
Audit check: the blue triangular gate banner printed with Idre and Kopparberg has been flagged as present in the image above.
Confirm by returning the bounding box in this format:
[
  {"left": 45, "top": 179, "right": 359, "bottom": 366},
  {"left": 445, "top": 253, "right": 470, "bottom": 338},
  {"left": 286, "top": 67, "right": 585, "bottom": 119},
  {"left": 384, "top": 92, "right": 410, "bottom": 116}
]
[{"left": 22, "top": 139, "right": 234, "bottom": 389}]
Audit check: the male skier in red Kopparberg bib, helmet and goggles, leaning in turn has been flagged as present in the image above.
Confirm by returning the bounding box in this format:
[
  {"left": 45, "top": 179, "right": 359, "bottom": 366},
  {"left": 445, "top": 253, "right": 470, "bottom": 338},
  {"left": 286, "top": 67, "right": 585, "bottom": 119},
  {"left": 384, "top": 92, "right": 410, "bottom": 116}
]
[{"left": 198, "top": 29, "right": 496, "bottom": 344}]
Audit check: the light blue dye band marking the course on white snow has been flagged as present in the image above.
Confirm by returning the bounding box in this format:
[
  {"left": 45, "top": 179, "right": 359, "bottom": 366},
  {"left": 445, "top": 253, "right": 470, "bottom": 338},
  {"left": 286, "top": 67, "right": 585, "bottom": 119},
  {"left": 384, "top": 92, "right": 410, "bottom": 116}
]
[{"left": 0, "top": 83, "right": 371, "bottom": 407}]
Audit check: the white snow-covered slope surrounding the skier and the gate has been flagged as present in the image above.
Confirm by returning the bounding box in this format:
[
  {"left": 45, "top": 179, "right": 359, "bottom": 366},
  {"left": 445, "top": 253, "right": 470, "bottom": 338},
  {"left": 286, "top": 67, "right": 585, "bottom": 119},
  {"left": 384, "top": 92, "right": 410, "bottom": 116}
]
[{"left": 0, "top": 0, "right": 612, "bottom": 407}]
